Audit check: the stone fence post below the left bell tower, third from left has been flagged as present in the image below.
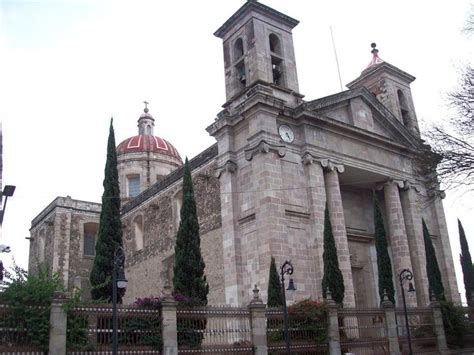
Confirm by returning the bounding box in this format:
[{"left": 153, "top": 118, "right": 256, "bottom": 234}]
[{"left": 249, "top": 285, "right": 268, "bottom": 355}]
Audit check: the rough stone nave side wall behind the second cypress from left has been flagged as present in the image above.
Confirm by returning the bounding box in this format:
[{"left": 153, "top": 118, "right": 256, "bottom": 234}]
[{"left": 122, "top": 162, "right": 224, "bottom": 303}]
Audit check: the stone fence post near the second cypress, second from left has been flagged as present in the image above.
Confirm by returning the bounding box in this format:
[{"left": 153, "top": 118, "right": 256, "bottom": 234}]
[{"left": 161, "top": 286, "right": 178, "bottom": 355}]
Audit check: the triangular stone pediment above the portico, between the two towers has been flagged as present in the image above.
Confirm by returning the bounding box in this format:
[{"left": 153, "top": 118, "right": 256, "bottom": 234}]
[{"left": 295, "top": 88, "right": 419, "bottom": 149}]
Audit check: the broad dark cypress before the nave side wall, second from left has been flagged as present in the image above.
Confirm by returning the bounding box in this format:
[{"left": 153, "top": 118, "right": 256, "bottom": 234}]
[{"left": 173, "top": 158, "right": 209, "bottom": 304}]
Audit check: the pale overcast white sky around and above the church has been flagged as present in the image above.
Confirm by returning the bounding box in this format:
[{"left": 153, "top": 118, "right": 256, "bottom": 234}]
[{"left": 0, "top": 0, "right": 474, "bottom": 304}]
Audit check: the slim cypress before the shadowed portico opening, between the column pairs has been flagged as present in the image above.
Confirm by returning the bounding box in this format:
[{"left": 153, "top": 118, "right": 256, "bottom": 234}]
[{"left": 373, "top": 192, "right": 395, "bottom": 304}]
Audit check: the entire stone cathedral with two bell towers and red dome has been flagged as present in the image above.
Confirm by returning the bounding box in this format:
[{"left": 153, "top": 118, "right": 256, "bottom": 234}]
[{"left": 29, "top": 0, "right": 460, "bottom": 307}]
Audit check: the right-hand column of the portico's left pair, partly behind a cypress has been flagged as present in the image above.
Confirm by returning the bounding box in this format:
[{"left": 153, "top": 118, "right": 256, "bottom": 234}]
[{"left": 321, "top": 159, "right": 355, "bottom": 307}]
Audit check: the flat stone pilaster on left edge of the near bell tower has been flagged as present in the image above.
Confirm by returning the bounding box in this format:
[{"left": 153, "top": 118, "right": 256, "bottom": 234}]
[{"left": 218, "top": 160, "right": 243, "bottom": 305}]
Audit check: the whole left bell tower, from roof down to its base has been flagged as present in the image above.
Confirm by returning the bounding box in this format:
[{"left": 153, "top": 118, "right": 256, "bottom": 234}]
[{"left": 207, "top": 0, "right": 312, "bottom": 305}]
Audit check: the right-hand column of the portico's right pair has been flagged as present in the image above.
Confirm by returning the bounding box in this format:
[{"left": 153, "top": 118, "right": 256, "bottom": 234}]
[{"left": 400, "top": 182, "right": 430, "bottom": 306}]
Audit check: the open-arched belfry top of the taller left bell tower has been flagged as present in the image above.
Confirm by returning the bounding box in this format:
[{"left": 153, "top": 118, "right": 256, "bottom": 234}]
[{"left": 214, "top": 0, "right": 300, "bottom": 106}]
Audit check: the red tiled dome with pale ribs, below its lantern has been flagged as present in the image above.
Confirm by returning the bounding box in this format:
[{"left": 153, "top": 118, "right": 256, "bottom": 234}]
[{"left": 117, "top": 134, "right": 182, "bottom": 161}]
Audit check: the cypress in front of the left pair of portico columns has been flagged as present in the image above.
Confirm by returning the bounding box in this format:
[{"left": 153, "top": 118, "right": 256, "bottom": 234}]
[{"left": 322, "top": 202, "right": 344, "bottom": 305}]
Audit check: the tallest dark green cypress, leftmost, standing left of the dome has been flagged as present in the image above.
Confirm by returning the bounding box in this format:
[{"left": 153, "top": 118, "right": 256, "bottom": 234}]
[{"left": 90, "top": 119, "right": 124, "bottom": 302}]
